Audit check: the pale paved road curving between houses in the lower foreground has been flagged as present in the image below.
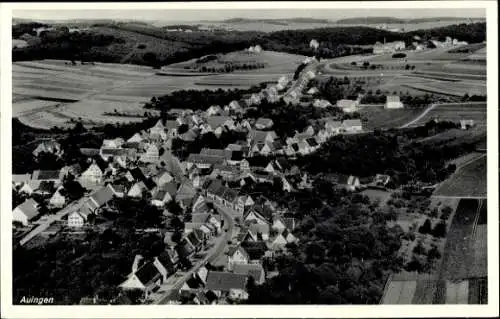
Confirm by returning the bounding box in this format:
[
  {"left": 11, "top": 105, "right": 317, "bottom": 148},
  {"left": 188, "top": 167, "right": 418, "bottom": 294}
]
[{"left": 152, "top": 203, "right": 234, "bottom": 304}]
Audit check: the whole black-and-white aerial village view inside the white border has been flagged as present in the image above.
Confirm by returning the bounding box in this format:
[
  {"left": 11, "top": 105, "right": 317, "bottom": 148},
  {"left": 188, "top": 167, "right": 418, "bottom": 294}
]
[{"left": 8, "top": 5, "right": 491, "bottom": 305}]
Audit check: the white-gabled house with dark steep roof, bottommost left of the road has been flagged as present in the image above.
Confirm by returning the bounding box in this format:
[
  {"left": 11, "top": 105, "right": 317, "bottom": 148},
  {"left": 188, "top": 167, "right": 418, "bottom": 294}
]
[{"left": 120, "top": 259, "right": 166, "bottom": 298}]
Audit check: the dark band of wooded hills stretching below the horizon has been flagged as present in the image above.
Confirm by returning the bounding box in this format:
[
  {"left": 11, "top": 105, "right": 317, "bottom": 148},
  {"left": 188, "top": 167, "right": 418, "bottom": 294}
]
[{"left": 12, "top": 22, "right": 486, "bottom": 68}]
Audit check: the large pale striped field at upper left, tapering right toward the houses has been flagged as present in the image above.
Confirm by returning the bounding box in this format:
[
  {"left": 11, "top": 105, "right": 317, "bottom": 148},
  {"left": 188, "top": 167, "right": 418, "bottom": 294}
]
[{"left": 12, "top": 55, "right": 292, "bottom": 128}]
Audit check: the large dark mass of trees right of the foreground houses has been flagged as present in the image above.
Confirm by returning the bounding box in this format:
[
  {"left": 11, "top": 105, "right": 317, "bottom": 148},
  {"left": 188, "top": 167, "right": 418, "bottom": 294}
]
[{"left": 248, "top": 179, "right": 403, "bottom": 304}]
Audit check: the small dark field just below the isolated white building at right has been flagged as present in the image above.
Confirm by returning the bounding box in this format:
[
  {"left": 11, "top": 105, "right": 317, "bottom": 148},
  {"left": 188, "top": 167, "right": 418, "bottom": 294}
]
[{"left": 359, "top": 105, "right": 422, "bottom": 130}]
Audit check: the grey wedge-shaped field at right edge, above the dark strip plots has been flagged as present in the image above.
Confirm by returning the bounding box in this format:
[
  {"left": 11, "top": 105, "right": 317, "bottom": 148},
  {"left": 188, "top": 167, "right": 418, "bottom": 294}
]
[{"left": 434, "top": 156, "right": 487, "bottom": 197}]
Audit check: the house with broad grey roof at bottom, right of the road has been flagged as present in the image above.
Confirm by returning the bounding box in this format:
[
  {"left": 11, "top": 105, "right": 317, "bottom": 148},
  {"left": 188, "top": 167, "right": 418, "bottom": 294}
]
[{"left": 206, "top": 271, "right": 248, "bottom": 300}]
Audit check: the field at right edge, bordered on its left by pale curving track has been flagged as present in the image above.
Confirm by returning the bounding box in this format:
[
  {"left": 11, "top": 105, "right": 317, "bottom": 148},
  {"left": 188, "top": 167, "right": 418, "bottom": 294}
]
[{"left": 413, "top": 103, "right": 487, "bottom": 127}]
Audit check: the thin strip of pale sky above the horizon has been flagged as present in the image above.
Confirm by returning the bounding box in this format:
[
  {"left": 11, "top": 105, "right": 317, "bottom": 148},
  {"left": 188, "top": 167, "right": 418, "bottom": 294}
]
[{"left": 12, "top": 9, "right": 485, "bottom": 22}]
